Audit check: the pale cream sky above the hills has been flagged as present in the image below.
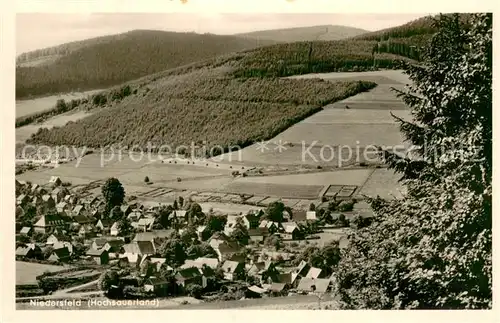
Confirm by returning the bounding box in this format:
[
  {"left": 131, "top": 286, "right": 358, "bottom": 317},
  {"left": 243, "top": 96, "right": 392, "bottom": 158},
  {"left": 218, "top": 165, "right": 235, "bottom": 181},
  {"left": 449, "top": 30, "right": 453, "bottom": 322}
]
[{"left": 16, "top": 13, "right": 427, "bottom": 55}]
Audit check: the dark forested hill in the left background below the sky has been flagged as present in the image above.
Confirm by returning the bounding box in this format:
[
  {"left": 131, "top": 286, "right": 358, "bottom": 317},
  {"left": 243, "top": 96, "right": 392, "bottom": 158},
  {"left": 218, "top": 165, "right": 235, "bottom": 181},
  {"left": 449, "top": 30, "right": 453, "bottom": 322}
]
[{"left": 16, "top": 30, "right": 276, "bottom": 99}]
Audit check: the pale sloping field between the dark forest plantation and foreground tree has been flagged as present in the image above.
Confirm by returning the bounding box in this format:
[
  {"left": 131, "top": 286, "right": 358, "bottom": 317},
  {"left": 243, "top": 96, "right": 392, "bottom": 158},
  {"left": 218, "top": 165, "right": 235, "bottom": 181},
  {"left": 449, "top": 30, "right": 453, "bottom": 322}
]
[{"left": 222, "top": 71, "right": 411, "bottom": 167}]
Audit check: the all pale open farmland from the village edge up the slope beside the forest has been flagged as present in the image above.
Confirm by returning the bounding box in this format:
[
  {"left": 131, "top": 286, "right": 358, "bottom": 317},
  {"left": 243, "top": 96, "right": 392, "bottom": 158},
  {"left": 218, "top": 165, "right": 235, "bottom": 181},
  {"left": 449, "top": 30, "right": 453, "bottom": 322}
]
[{"left": 18, "top": 71, "right": 411, "bottom": 213}]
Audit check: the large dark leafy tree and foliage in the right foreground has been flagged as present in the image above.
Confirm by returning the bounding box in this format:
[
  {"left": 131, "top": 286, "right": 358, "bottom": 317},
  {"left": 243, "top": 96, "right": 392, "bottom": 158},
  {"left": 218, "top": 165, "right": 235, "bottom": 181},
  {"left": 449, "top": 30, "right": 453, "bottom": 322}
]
[{"left": 337, "top": 14, "right": 492, "bottom": 309}]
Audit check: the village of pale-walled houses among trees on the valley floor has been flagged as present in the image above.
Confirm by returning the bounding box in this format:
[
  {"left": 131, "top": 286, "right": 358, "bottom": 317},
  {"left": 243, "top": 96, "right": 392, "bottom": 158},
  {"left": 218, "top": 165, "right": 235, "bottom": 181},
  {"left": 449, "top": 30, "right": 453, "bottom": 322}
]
[{"left": 15, "top": 171, "right": 369, "bottom": 308}]
